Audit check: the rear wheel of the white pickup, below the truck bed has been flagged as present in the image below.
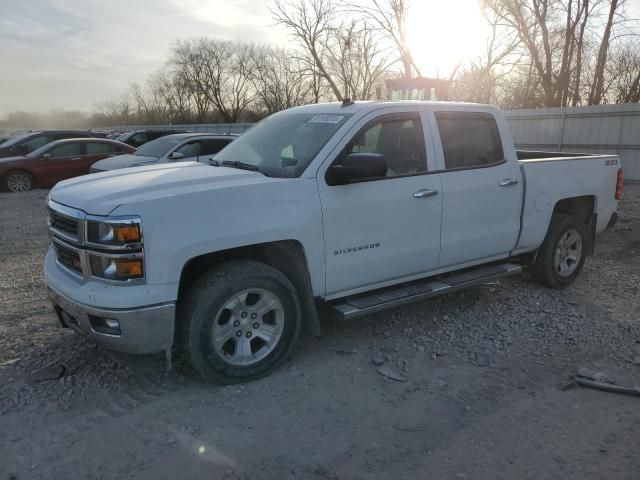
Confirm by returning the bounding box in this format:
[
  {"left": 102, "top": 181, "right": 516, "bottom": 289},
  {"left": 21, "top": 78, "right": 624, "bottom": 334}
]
[{"left": 532, "top": 214, "right": 589, "bottom": 289}]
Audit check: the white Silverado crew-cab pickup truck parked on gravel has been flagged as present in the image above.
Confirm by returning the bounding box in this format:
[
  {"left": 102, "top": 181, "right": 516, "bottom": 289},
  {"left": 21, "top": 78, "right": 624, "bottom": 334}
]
[{"left": 45, "top": 101, "right": 622, "bottom": 383}]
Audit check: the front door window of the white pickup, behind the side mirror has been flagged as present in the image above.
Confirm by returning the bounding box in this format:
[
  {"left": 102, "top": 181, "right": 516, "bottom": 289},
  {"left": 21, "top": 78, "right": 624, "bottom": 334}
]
[{"left": 345, "top": 113, "right": 427, "bottom": 177}]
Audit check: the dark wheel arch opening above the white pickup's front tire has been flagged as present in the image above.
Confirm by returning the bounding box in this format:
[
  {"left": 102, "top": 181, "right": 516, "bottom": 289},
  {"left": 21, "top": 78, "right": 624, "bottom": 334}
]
[{"left": 176, "top": 240, "right": 320, "bottom": 335}]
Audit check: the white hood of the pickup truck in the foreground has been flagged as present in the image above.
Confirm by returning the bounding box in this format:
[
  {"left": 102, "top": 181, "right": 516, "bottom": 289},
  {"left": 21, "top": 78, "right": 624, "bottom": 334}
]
[{"left": 49, "top": 162, "right": 270, "bottom": 215}]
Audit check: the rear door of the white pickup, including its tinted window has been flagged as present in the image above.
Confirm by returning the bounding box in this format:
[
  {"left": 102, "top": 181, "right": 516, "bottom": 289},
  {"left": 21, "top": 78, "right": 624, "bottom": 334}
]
[{"left": 430, "top": 109, "right": 522, "bottom": 267}]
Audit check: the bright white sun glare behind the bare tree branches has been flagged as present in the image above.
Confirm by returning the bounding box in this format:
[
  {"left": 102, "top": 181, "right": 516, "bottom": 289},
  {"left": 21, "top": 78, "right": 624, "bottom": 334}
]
[{"left": 407, "top": 0, "right": 489, "bottom": 77}]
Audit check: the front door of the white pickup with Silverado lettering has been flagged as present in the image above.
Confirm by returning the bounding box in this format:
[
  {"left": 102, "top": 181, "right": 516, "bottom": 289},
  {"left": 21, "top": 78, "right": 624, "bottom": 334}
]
[{"left": 318, "top": 108, "right": 442, "bottom": 297}]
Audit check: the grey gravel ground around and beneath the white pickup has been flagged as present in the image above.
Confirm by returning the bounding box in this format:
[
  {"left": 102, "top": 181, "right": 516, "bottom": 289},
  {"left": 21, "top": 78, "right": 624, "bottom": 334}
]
[{"left": 0, "top": 184, "right": 640, "bottom": 480}]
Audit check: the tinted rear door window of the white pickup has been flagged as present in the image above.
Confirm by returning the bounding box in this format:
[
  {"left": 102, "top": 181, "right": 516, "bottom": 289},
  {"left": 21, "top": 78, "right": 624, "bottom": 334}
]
[{"left": 436, "top": 112, "right": 504, "bottom": 170}]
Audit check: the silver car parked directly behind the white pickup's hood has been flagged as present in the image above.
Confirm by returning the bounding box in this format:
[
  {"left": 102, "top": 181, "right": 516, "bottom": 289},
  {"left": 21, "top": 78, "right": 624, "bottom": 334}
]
[{"left": 91, "top": 133, "right": 237, "bottom": 173}]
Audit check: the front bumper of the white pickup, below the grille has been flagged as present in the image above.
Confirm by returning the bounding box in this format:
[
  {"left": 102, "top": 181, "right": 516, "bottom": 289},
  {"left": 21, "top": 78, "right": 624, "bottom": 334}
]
[{"left": 47, "top": 285, "right": 176, "bottom": 354}]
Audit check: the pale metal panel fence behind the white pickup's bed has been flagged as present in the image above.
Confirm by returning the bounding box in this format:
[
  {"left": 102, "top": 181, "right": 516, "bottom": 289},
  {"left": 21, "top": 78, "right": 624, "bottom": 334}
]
[{"left": 505, "top": 103, "right": 640, "bottom": 180}]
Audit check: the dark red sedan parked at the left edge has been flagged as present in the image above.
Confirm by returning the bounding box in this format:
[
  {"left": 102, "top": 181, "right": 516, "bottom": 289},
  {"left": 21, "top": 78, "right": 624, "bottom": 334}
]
[{"left": 0, "top": 138, "right": 136, "bottom": 192}]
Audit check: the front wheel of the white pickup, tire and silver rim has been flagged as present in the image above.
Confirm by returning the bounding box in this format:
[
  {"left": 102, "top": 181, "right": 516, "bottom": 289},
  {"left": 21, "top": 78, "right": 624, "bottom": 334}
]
[{"left": 178, "top": 260, "right": 302, "bottom": 384}]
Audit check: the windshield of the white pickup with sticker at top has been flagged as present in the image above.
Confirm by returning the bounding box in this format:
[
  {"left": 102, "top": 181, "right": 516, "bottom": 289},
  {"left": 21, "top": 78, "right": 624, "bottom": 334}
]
[{"left": 215, "top": 112, "right": 351, "bottom": 177}]
